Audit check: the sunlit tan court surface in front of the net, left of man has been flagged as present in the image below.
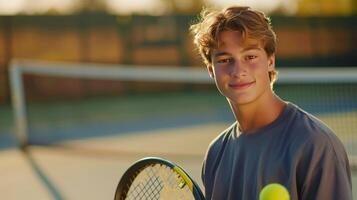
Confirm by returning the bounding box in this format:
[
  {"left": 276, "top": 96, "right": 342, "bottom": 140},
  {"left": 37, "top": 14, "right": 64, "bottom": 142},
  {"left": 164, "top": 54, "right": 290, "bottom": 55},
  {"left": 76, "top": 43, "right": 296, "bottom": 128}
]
[{"left": 0, "top": 123, "right": 227, "bottom": 200}]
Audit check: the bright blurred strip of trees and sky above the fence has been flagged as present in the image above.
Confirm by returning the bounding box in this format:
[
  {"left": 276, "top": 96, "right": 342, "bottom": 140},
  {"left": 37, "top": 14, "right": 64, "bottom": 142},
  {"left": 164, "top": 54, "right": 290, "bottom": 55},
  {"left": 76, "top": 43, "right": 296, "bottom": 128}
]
[{"left": 0, "top": 0, "right": 356, "bottom": 16}]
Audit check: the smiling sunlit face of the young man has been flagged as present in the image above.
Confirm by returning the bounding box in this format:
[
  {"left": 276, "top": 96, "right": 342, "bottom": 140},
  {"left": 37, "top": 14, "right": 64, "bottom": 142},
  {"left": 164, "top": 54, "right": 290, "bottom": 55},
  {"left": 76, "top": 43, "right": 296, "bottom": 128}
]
[{"left": 207, "top": 31, "right": 275, "bottom": 105}]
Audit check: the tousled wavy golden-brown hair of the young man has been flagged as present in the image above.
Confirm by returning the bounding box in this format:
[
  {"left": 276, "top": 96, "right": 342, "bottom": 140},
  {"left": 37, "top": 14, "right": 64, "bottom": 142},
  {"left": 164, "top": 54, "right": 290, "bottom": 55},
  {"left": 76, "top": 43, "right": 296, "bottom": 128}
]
[{"left": 190, "top": 6, "right": 277, "bottom": 84}]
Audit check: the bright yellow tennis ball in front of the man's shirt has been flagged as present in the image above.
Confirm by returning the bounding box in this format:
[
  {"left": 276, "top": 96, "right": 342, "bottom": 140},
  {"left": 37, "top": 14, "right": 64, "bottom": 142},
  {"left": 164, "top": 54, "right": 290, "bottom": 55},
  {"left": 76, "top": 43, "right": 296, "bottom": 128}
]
[{"left": 259, "top": 183, "right": 290, "bottom": 200}]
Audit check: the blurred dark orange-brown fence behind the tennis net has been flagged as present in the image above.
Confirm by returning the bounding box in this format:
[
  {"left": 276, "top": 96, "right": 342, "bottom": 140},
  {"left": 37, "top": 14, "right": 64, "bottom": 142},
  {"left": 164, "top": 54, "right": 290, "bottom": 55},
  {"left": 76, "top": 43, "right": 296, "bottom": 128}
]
[{"left": 0, "top": 14, "right": 357, "bottom": 104}]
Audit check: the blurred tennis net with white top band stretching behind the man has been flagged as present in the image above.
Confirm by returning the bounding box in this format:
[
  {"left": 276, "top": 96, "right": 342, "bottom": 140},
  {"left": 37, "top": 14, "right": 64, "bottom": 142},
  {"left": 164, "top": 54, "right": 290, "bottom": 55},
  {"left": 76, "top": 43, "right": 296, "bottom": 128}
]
[{"left": 10, "top": 60, "right": 357, "bottom": 166}]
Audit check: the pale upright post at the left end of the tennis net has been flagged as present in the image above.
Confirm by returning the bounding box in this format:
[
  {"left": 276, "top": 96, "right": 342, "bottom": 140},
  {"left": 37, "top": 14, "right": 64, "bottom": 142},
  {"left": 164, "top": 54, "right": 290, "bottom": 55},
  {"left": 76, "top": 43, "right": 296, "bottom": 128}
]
[{"left": 9, "top": 61, "right": 28, "bottom": 149}]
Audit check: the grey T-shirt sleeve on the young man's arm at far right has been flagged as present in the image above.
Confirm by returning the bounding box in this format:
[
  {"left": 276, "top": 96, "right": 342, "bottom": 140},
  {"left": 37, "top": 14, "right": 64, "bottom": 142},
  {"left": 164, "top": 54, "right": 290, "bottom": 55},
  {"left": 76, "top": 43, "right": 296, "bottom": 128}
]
[{"left": 299, "top": 135, "right": 352, "bottom": 200}]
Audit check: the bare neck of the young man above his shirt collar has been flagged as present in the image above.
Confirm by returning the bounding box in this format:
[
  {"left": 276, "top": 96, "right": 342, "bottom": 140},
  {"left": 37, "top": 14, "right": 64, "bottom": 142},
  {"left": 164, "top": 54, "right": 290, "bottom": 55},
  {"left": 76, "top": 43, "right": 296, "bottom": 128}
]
[{"left": 230, "top": 93, "right": 286, "bottom": 132}]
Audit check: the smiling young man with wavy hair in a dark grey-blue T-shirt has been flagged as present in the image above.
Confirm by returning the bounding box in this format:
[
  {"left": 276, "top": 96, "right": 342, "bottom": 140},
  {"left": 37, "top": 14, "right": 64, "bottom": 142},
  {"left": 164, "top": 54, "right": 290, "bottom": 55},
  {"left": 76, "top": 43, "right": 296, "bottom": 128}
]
[{"left": 191, "top": 7, "right": 352, "bottom": 200}]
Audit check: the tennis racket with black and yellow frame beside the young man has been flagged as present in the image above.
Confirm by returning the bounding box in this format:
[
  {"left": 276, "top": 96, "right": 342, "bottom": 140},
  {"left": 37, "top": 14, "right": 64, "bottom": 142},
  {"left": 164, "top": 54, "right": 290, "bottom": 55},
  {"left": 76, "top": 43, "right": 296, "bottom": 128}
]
[{"left": 114, "top": 157, "right": 205, "bottom": 200}]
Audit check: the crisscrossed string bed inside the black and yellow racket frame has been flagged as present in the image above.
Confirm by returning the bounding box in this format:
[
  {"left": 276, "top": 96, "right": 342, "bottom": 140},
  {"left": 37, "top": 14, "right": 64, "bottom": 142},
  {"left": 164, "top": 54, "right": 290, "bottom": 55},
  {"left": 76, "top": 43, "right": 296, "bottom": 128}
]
[{"left": 126, "top": 164, "right": 194, "bottom": 200}]
